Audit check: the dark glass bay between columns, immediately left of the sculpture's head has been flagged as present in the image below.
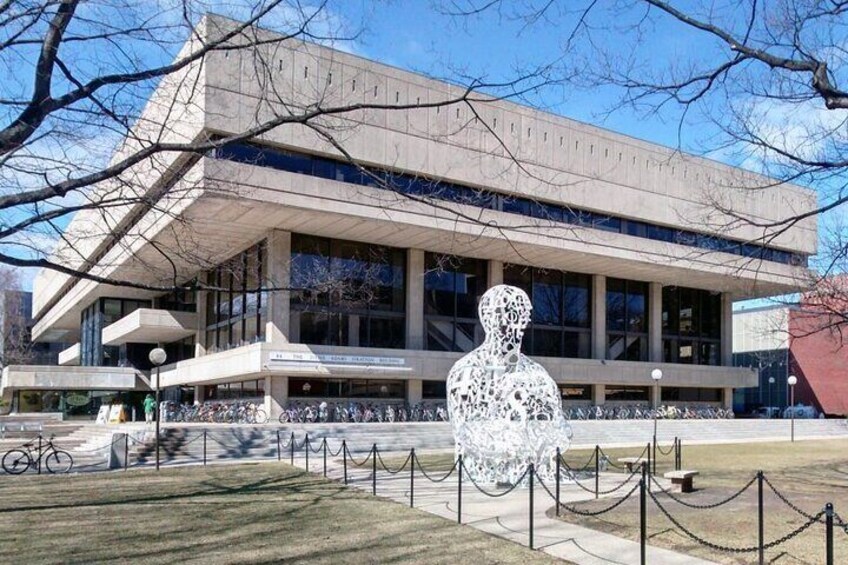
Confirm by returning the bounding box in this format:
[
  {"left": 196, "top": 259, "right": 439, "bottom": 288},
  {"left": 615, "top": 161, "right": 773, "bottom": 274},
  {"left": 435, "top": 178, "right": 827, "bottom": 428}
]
[{"left": 424, "top": 253, "right": 487, "bottom": 352}]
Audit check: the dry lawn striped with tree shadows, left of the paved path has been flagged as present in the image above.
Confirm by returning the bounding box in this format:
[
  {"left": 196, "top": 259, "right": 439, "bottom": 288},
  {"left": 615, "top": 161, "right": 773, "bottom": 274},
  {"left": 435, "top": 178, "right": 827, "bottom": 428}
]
[{"left": 0, "top": 463, "right": 568, "bottom": 563}]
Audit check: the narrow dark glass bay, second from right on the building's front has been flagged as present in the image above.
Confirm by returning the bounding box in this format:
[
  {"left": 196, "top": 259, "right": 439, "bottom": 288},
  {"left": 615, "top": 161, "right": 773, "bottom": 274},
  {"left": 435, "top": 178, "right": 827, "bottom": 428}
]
[{"left": 607, "top": 279, "right": 648, "bottom": 361}]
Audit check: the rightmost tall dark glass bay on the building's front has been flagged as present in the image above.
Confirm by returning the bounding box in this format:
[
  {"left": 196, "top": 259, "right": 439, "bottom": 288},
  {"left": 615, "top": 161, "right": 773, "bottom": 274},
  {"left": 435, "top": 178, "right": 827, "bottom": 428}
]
[{"left": 662, "top": 286, "right": 721, "bottom": 365}]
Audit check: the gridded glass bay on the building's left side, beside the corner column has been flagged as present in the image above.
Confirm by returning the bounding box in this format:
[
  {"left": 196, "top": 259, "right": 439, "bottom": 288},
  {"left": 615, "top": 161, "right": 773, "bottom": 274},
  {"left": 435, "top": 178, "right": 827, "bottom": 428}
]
[{"left": 206, "top": 241, "right": 267, "bottom": 352}]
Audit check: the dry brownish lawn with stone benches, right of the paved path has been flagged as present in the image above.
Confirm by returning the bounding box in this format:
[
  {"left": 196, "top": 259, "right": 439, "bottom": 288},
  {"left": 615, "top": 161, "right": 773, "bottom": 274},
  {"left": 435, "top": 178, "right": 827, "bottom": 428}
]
[{"left": 406, "top": 439, "right": 848, "bottom": 565}]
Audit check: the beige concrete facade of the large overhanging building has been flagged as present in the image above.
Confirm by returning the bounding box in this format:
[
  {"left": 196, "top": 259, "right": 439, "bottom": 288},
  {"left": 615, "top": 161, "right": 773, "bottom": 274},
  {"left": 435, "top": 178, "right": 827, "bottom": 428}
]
[{"left": 18, "top": 17, "right": 816, "bottom": 416}]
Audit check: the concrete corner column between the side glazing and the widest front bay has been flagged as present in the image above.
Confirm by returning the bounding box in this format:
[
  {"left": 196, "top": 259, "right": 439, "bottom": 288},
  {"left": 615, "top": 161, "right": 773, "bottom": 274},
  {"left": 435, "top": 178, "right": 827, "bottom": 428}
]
[{"left": 264, "top": 230, "right": 291, "bottom": 344}]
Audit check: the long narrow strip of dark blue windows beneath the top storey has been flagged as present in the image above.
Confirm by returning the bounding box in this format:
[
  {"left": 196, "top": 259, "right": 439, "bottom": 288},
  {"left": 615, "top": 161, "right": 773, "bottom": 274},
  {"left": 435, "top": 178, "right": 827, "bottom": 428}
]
[{"left": 212, "top": 144, "right": 807, "bottom": 265}]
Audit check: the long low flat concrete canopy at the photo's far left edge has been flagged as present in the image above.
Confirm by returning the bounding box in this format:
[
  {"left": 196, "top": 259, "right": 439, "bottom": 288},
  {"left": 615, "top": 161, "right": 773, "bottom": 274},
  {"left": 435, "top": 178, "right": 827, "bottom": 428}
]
[{"left": 0, "top": 365, "right": 139, "bottom": 396}]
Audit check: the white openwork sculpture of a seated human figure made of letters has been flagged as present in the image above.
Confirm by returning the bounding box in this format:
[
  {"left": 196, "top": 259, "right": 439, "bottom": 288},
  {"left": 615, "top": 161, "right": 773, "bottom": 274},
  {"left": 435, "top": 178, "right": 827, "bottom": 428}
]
[{"left": 447, "top": 285, "right": 571, "bottom": 484}]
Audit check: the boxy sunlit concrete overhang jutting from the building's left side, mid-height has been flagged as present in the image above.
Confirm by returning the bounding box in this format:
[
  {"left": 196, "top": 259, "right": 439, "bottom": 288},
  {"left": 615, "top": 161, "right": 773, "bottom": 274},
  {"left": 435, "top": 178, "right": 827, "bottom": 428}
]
[{"left": 102, "top": 308, "right": 197, "bottom": 345}]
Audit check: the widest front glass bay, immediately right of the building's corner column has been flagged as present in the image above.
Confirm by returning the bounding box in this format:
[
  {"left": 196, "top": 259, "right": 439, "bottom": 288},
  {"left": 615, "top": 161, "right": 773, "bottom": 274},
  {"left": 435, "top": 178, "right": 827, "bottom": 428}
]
[{"left": 291, "top": 234, "right": 406, "bottom": 349}]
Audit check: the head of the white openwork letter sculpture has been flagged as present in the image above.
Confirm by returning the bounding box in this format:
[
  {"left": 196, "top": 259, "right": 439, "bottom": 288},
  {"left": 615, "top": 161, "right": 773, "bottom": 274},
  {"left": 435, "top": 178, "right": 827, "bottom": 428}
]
[{"left": 477, "top": 284, "right": 533, "bottom": 351}]
